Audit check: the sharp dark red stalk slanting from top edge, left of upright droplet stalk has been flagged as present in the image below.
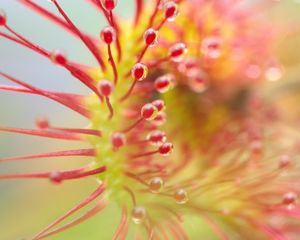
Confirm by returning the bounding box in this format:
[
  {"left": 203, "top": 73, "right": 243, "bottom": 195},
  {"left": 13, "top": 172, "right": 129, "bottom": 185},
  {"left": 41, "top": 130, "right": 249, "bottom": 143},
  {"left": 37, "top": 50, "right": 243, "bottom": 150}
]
[{"left": 52, "top": 0, "right": 106, "bottom": 71}]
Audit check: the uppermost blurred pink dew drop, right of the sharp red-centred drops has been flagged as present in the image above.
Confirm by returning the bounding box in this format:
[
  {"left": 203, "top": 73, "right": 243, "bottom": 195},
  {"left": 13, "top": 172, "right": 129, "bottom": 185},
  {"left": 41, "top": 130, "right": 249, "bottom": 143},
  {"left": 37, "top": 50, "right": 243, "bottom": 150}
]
[{"left": 200, "top": 36, "right": 222, "bottom": 59}]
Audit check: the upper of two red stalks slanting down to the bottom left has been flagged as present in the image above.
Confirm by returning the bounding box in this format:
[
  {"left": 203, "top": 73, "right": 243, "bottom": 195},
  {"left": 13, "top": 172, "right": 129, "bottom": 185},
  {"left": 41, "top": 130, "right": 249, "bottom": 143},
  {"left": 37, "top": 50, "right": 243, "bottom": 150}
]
[{"left": 33, "top": 184, "right": 105, "bottom": 240}]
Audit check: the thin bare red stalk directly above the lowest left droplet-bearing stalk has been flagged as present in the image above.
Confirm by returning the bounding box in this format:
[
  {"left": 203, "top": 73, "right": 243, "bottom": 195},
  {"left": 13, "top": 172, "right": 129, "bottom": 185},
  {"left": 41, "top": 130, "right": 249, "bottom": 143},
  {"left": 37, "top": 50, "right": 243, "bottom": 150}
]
[{"left": 0, "top": 148, "right": 96, "bottom": 162}]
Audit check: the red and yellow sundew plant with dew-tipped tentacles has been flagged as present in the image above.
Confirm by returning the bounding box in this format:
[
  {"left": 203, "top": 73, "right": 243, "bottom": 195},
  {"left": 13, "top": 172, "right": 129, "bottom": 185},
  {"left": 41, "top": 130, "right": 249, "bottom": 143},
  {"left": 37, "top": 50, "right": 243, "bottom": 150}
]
[{"left": 0, "top": 0, "right": 300, "bottom": 240}]
